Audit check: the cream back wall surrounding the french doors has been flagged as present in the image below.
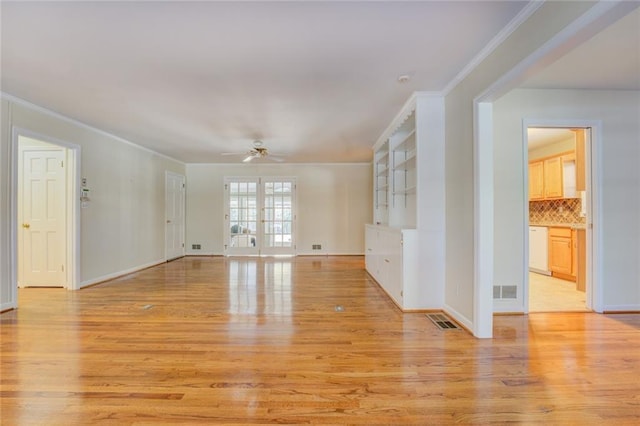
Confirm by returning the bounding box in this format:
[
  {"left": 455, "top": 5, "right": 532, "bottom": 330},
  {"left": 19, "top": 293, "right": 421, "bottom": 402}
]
[{"left": 186, "top": 164, "right": 373, "bottom": 255}]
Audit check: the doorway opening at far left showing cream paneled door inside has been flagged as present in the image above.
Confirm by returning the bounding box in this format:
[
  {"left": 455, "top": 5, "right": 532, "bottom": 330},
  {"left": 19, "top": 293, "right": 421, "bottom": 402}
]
[{"left": 11, "top": 133, "right": 79, "bottom": 289}]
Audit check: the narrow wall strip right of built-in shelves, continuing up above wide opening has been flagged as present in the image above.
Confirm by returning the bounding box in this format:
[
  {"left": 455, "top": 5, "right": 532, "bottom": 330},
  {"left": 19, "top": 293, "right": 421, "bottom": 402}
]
[{"left": 444, "top": 2, "right": 593, "bottom": 327}]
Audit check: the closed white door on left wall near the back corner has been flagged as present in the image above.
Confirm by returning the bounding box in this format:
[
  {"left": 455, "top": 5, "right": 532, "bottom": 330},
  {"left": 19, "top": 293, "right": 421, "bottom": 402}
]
[{"left": 165, "top": 172, "right": 185, "bottom": 260}]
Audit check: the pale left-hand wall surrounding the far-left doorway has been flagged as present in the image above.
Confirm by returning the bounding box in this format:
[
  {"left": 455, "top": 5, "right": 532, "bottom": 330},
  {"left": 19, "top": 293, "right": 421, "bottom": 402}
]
[{"left": 0, "top": 99, "right": 185, "bottom": 306}]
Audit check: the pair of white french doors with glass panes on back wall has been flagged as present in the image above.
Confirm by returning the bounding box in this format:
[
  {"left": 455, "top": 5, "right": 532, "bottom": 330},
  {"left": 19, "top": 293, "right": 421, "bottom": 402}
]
[{"left": 224, "top": 177, "right": 296, "bottom": 256}]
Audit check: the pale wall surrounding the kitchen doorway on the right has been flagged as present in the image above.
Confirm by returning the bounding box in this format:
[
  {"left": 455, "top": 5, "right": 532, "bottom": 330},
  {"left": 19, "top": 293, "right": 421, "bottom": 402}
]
[{"left": 494, "top": 90, "right": 640, "bottom": 311}]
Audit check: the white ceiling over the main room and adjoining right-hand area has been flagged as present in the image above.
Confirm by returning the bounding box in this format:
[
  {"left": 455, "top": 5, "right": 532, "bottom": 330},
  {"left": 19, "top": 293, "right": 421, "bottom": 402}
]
[{"left": 0, "top": 1, "right": 640, "bottom": 162}]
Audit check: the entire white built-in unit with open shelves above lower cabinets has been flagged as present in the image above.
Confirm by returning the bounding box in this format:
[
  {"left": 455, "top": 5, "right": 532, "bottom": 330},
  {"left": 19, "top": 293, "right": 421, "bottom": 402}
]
[{"left": 365, "top": 93, "right": 445, "bottom": 310}]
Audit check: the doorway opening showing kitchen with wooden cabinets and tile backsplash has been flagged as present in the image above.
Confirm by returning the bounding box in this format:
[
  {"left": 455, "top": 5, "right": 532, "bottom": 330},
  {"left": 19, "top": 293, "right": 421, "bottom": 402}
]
[{"left": 525, "top": 127, "right": 593, "bottom": 312}]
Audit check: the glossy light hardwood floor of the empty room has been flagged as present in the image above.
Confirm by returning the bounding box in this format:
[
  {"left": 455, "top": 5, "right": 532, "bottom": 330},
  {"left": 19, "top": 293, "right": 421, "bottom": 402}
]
[{"left": 0, "top": 257, "right": 640, "bottom": 425}]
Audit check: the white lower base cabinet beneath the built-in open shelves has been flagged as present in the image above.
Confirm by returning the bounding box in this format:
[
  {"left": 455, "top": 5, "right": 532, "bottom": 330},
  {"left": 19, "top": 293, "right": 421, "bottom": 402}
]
[{"left": 365, "top": 225, "right": 420, "bottom": 310}]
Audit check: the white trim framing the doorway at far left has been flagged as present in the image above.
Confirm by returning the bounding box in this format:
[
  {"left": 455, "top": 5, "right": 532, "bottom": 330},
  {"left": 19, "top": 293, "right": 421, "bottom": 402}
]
[{"left": 9, "top": 126, "right": 81, "bottom": 292}]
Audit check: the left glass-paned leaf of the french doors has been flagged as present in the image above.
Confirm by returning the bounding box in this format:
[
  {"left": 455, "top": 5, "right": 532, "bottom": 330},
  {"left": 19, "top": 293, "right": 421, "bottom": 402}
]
[{"left": 225, "top": 178, "right": 260, "bottom": 255}]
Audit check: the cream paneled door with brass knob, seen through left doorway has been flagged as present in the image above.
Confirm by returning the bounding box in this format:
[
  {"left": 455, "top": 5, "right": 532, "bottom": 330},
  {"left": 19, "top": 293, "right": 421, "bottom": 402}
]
[{"left": 18, "top": 145, "right": 67, "bottom": 287}]
